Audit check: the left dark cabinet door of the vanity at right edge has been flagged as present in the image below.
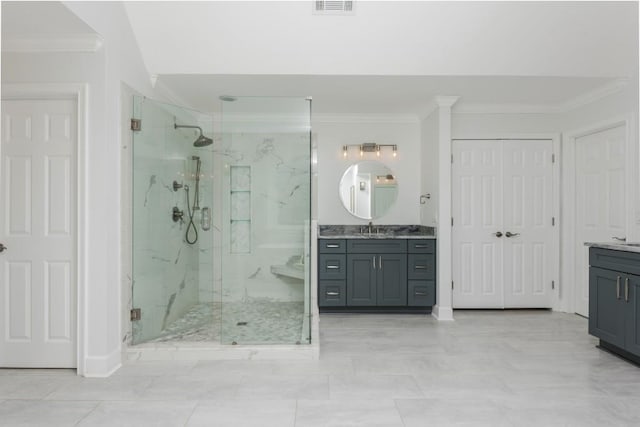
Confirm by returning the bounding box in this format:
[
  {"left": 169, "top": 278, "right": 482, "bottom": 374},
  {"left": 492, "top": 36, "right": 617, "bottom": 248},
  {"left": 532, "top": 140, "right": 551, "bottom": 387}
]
[{"left": 589, "top": 267, "right": 626, "bottom": 348}]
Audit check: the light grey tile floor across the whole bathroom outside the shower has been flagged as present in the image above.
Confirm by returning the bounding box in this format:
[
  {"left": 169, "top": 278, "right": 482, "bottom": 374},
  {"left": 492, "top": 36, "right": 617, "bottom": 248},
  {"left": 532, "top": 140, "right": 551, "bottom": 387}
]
[{"left": 0, "top": 311, "right": 640, "bottom": 427}]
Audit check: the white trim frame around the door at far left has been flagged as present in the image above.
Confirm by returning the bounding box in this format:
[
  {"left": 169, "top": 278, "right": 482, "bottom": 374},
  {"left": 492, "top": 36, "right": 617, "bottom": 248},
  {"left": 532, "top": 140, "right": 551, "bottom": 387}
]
[{"left": 2, "top": 83, "right": 89, "bottom": 375}]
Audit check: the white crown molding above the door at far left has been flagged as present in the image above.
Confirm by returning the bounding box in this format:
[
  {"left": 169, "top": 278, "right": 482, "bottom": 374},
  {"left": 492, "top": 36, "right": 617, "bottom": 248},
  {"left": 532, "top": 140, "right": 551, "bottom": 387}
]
[{"left": 2, "top": 33, "right": 103, "bottom": 53}]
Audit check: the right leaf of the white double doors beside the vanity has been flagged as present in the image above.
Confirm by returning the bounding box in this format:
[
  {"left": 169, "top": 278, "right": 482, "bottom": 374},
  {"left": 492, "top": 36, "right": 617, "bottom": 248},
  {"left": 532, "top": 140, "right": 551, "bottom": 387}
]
[{"left": 502, "top": 140, "right": 554, "bottom": 308}]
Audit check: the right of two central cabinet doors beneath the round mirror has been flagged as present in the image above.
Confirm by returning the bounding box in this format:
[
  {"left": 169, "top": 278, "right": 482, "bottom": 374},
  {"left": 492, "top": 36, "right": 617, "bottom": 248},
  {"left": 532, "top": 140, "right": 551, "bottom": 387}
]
[{"left": 376, "top": 254, "right": 407, "bottom": 306}]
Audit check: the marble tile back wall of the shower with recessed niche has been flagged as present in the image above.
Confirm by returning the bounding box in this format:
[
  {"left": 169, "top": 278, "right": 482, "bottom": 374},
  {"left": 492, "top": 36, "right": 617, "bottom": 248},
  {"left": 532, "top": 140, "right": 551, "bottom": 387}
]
[{"left": 219, "top": 132, "right": 310, "bottom": 301}]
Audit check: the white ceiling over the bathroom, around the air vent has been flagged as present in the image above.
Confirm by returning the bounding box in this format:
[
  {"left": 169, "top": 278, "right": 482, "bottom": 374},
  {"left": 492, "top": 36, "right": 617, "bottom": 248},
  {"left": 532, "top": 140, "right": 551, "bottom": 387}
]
[{"left": 2, "top": 0, "right": 638, "bottom": 115}]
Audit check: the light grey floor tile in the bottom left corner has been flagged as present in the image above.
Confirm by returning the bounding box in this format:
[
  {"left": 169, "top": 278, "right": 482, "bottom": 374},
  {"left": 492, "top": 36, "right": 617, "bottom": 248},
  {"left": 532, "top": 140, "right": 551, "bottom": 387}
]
[{"left": 0, "top": 400, "right": 98, "bottom": 427}]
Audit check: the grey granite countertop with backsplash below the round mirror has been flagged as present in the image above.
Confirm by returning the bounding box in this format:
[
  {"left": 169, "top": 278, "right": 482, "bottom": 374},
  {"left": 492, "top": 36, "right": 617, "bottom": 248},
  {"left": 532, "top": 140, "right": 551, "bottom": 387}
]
[{"left": 318, "top": 224, "right": 436, "bottom": 239}]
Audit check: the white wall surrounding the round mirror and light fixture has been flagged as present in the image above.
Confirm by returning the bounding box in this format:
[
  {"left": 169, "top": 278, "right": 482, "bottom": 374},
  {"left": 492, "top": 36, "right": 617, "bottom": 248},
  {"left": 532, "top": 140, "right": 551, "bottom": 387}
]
[{"left": 312, "top": 116, "right": 421, "bottom": 224}]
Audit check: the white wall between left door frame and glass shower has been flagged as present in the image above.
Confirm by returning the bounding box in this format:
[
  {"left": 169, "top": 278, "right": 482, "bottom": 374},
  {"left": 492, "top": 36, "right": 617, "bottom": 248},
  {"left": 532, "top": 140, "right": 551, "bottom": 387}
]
[{"left": 2, "top": 2, "right": 152, "bottom": 376}]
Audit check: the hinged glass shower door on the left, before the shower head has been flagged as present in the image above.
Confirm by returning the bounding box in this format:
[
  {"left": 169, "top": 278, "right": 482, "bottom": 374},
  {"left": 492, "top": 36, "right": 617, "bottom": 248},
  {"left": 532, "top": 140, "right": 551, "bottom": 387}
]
[{"left": 131, "top": 97, "right": 219, "bottom": 344}]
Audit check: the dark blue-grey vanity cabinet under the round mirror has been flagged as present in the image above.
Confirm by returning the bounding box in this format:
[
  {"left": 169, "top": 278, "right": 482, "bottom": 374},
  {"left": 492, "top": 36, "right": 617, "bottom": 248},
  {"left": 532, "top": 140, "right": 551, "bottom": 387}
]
[{"left": 318, "top": 239, "right": 436, "bottom": 310}]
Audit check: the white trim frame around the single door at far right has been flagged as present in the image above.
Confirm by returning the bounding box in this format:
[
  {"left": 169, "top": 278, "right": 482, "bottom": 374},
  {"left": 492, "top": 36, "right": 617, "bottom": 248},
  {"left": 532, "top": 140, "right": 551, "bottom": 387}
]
[{"left": 560, "top": 115, "right": 640, "bottom": 313}]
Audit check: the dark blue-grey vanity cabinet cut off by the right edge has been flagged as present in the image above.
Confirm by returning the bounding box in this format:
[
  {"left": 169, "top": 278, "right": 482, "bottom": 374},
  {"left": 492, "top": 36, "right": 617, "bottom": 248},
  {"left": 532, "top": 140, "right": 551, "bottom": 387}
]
[{"left": 589, "top": 247, "right": 640, "bottom": 363}]
